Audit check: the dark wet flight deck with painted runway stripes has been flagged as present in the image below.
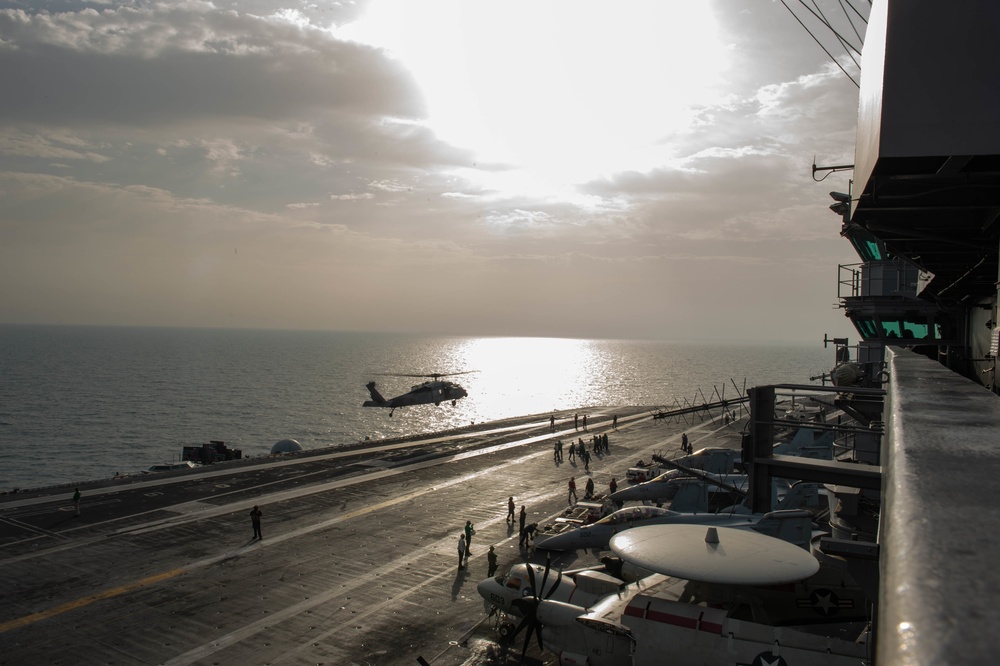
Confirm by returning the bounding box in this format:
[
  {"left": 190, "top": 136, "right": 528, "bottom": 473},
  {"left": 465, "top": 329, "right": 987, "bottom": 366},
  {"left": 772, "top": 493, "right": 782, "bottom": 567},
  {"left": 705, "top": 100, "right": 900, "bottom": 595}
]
[{"left": 0, "top": 408, "right": 739, "bottom": 666}]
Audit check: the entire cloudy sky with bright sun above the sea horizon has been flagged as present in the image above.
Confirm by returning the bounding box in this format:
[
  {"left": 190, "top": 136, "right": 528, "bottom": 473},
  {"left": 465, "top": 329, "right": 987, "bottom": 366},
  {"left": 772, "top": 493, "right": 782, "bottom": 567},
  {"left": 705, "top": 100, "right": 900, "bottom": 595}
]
[{"left": 0, "top": 0, "right": 867, "bottom": 342}]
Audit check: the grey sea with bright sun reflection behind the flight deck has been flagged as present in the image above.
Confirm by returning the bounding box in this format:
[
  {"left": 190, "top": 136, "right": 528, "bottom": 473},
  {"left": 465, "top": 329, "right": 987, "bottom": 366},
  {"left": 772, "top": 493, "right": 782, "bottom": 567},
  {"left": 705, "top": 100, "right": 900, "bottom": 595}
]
[{"left": 0, "top": 325, "right": 833, "bottom": 491}]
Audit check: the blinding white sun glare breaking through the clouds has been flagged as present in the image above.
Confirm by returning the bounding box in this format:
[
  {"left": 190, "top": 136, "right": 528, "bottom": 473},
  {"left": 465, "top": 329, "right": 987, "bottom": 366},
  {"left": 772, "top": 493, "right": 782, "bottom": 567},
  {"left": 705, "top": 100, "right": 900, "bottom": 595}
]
[{"left": 341, "top": 0, "right": 726, "bottom": 187}]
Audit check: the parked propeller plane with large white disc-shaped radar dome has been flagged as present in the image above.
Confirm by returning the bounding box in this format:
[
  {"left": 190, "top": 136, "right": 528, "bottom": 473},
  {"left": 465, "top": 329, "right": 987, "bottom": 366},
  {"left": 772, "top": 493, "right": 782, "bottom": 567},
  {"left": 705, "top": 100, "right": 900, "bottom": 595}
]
[{"left": 488, "top": 525, "right": 870, "bottom": 666}]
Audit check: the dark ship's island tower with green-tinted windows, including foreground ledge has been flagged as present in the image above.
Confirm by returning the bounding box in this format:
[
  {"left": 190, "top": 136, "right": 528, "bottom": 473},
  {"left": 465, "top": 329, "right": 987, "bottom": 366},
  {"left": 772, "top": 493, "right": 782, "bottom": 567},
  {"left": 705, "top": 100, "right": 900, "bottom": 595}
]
[{"left": 744, "top": 0, "right": 1000, "bottom": 664}]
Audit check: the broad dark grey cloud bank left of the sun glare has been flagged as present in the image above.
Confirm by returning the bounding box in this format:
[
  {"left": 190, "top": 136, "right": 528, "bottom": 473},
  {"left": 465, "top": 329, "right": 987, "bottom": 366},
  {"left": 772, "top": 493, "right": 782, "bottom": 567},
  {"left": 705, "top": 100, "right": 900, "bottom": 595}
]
[{"left": 0, "top": 4, "right": 424, "bottom": 127}]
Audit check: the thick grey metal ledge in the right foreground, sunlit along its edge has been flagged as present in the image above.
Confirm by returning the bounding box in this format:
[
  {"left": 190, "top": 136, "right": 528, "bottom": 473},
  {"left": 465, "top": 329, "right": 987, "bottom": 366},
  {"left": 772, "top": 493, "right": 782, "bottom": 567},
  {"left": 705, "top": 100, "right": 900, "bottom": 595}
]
[{"left": 877, "top": 347, "right": 1000, "bottom": 665}]
